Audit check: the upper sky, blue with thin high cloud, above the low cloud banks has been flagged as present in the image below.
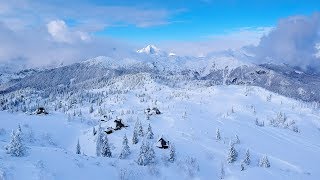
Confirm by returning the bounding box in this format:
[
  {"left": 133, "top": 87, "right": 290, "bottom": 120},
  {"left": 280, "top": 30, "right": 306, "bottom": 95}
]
[{"left": 0, "top": 0, "right": 320, "bottom": 43}]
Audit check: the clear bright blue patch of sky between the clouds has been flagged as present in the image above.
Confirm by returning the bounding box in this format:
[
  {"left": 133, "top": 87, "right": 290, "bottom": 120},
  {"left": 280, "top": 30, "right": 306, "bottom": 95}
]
[{"left": 85, "top": 0, "right": 320, "bottom": 42}]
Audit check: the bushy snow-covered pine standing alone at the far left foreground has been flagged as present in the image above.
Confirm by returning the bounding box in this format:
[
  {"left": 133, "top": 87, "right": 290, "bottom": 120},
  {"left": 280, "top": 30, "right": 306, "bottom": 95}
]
[{"left": 6, "top": 128, "right": 26, "bottom": 157}]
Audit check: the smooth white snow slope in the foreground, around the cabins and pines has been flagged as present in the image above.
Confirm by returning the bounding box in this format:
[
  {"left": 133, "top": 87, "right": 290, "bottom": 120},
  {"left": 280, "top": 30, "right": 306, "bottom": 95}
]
[{"left": 0, "top": 83, "right": 320, "bottom": 180}]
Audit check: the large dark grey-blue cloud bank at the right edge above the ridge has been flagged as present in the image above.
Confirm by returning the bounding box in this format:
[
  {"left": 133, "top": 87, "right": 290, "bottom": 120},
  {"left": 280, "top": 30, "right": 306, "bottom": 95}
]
[{"left": 253, "top": 13, "right": 320, "bottom": 72}]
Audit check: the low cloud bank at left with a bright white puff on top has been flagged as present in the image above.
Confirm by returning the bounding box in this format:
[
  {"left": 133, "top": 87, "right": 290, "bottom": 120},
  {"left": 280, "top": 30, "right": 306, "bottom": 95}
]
[{"left": 0, "top": 21, "right": 134, "bottom": 67}]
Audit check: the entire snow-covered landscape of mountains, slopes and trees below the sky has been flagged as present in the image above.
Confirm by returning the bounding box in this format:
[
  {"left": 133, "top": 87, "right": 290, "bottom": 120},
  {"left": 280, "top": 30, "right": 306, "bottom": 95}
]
[{"left": 0, "top": 46, "right": 320, "bottom": 180}]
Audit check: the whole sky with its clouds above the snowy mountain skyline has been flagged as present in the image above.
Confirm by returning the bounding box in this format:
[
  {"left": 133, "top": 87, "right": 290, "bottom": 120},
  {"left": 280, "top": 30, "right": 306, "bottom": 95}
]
[{"left": 0, "top": 0, "right": 320, "bottom": 64}]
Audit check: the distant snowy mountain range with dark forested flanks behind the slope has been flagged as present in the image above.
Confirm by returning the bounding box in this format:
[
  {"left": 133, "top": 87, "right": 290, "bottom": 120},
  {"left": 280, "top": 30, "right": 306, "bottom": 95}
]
[{"left": 0, "top": 47, "right": 320, "bottom": 102}]
